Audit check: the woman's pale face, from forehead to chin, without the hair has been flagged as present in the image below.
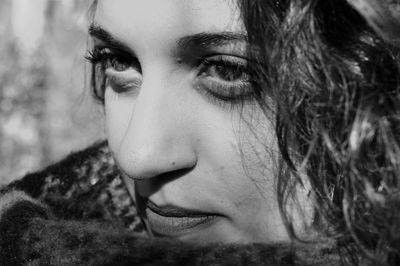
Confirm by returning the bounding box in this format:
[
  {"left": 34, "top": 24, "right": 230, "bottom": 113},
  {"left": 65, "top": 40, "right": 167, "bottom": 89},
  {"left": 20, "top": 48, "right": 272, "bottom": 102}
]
[{"left": 90, "top": 0, "right": 288, "bottom": 242}]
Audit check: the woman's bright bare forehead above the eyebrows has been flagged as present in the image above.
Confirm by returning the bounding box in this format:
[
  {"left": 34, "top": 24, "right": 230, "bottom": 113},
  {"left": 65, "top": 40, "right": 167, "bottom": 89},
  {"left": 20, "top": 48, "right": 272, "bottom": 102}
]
[{"left": 95, "top": 0, "right": 244, "bottom": 47}]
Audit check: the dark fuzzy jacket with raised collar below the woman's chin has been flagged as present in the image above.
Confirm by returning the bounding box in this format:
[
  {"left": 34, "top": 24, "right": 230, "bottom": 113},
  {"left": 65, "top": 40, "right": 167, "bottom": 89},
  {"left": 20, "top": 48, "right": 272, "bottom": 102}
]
[{"left": 0, "top": 142, "right": 340, "bottom": 266}]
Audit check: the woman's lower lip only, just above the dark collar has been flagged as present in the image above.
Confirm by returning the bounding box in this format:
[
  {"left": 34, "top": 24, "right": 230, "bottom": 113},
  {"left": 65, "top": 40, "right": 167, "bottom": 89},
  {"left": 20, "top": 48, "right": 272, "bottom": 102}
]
[{"left": 146, "top": 208, "right": 219, "bottom": 237}]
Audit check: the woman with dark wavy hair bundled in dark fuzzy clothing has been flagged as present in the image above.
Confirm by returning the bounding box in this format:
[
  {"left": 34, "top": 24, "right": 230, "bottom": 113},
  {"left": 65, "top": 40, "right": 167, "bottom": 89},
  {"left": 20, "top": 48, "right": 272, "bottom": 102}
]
[{"left": 0, "top": 0, "right": 400, "bottom": 265}]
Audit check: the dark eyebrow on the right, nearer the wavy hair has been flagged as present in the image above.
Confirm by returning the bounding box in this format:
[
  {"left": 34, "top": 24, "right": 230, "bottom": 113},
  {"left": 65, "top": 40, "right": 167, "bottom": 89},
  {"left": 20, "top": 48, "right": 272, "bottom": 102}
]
[{"left": 177, "top": 31, "right": 247, "bottom": 50}]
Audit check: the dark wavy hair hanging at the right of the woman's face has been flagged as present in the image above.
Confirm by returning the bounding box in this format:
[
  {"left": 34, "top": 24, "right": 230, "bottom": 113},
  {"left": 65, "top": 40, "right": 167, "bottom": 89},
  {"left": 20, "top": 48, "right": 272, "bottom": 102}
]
[{"left": 242, "top": 0, "right": 400, "bottom": 265}]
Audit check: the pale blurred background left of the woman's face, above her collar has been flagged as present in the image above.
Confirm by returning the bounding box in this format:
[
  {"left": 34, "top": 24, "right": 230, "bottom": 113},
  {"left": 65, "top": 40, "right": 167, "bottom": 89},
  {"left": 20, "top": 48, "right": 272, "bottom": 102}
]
[{"left": 0, "top": 0, "right": 104, "bottom": 185}]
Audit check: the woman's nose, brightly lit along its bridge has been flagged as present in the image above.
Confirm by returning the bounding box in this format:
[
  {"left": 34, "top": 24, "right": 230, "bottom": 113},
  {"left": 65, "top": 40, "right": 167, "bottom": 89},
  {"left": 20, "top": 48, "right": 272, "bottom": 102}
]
[{"left": 115, "top": 72, "right": 197, "bottom": 180}]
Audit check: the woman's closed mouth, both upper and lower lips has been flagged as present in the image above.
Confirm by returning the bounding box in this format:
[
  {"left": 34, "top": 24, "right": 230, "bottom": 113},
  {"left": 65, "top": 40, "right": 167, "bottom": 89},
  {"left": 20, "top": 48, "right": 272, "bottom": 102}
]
[{"left": 145, "top": 200, "right": 221, "bottom": 237}]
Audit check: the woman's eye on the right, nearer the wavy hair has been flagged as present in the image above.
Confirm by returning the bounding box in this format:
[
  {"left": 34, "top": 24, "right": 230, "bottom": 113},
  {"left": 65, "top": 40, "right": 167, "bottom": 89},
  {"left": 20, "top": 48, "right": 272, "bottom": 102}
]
[{"left": 198, "top": 55, "right": 253, "bottom": 102}]
